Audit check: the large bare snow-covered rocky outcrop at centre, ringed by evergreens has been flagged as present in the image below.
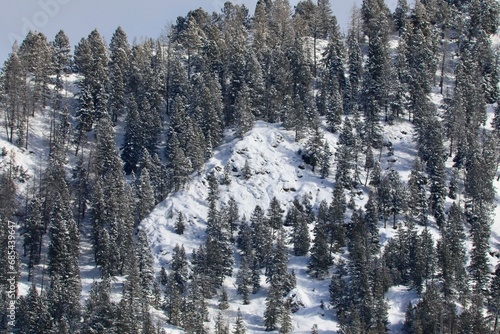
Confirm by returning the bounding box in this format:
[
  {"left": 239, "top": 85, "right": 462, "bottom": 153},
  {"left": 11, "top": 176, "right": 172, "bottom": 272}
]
[{"left": 142, "top": 122, "right": 337, "bottom": 263}]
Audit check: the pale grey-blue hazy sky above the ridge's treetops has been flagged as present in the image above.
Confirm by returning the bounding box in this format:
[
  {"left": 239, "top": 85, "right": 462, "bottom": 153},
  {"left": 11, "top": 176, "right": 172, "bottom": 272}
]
[{"left": 0, "top": 0, "right": 396, "bottom": 62}]
